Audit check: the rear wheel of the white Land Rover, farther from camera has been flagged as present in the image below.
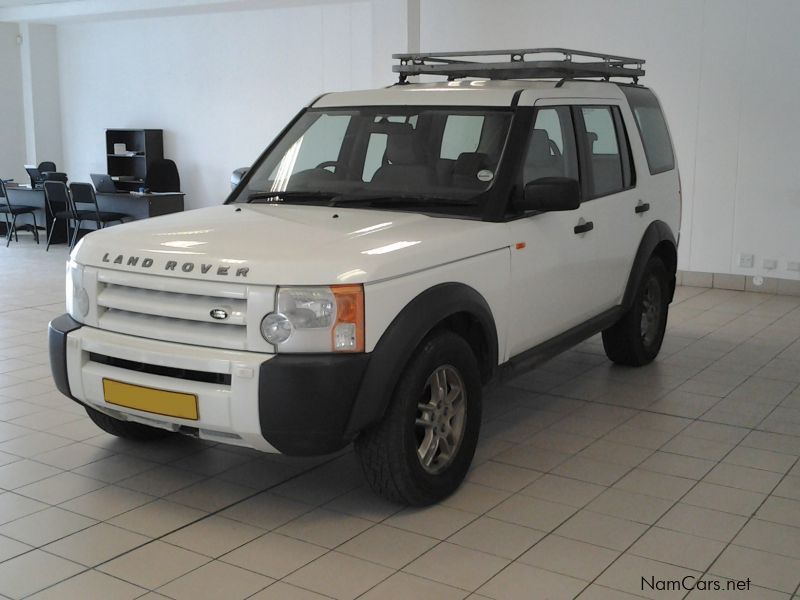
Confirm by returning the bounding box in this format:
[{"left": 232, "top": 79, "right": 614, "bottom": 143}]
[{"left": 603, "top": 256, "right": 670, "bottom": 367}]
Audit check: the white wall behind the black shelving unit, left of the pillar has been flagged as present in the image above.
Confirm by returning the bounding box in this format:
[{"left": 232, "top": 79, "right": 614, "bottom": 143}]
[{"left": 58, "top": 2, "right": 372, "bottom": 208}]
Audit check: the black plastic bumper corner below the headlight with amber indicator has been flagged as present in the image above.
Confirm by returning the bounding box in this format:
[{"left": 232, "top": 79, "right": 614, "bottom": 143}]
[{"left": 258, "top": 353, "right": 371, "bottom": 456}]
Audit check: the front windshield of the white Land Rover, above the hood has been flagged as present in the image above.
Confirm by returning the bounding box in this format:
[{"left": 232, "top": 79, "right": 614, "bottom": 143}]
[{"left": 234, "top": 106, "right": 511, "bottom": 211}]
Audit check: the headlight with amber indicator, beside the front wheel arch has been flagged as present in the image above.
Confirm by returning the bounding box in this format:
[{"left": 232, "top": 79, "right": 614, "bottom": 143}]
[{"left": 261, "top": 285, "right": 364, "bottom": 352}]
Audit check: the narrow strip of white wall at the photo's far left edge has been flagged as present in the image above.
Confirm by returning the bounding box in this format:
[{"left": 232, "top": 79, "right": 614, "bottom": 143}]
[{"left": 0, "top": 23, "right": 28, "bottom": 182}]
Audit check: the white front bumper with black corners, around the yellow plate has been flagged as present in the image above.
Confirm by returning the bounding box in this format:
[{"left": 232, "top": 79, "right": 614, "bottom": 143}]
[{"left": 49, "top": 315, "right": 369, "bottom": 455}]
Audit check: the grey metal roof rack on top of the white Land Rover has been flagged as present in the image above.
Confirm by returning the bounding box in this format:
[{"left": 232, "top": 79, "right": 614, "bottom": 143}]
[{"left": 392, "top": 48, "right": 645, "bottom": 83}]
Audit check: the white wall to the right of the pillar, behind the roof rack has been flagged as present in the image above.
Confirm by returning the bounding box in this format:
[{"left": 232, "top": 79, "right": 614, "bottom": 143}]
[{"left": 421, "top": 0, "right": 800, "bottom": 279}]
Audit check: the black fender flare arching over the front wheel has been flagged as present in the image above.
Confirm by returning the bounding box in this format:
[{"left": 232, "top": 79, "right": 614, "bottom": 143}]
[{"left": 346, "top": 282, "right": 498, "bottom": 436}]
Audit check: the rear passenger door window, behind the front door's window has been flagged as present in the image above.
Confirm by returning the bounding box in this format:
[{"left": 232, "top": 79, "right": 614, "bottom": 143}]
[{"left": 579, "top": 106, "right": 625, "bottom": 198}]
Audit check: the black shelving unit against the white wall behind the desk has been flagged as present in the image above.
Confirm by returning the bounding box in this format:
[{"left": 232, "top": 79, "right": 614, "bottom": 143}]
[{"left": 106, "top": 129, "right": 164, "bottom": 192}]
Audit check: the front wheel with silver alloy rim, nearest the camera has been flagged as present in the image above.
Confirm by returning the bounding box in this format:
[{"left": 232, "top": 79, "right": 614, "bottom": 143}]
[{"left": 355, "top": 331, "right": 482, "bottom": 506}]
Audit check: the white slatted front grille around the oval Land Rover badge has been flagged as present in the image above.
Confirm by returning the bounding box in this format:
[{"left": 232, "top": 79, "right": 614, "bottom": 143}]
[{"left": 96, "top": 270, "right": 248, "bottom": 350}]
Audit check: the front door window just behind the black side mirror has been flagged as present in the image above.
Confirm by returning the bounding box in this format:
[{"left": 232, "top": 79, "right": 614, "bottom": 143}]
[{"left": 522, "top": 106, "right": 578, "bottom": 183}]
